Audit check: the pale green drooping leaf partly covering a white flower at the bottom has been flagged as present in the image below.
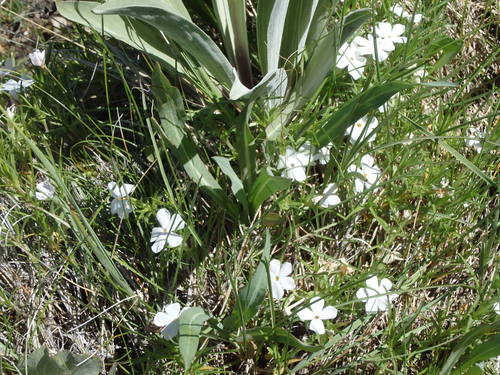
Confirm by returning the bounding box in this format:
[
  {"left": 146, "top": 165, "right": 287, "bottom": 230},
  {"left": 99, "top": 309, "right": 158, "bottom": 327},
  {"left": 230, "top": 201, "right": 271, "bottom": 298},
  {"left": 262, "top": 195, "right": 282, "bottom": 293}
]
[{"left": 179, "top": 307, "right": 209, "bottom": 370}]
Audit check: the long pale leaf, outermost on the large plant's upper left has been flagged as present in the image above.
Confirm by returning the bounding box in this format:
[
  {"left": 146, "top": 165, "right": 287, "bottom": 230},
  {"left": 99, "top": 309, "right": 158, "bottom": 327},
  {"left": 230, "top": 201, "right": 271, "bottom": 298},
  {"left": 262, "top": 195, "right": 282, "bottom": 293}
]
[{"left": 56, "top": 1, "right": 183, "bottom": 73}]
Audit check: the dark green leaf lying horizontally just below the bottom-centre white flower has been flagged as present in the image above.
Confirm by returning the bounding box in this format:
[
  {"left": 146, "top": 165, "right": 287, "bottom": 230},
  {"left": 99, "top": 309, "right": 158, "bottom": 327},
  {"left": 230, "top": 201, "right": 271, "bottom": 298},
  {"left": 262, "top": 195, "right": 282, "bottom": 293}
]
[{"left": 235, "top": 327, "right": 321, "bottom": 352}]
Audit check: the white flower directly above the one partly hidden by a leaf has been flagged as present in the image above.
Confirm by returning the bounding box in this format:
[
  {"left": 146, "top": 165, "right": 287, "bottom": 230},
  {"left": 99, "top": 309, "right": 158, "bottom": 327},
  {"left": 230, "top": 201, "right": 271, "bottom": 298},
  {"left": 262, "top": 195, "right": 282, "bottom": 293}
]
[{"left": 151, "top": 208, "right": 186, "bottom": 254}]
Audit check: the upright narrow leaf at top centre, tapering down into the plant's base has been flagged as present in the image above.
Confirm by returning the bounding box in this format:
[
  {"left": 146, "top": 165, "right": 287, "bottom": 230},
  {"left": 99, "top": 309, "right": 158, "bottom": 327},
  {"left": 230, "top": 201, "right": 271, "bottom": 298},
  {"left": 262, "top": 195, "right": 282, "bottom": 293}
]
[{"left": 213, "top": 0, "right": 252, "bottom": 86}]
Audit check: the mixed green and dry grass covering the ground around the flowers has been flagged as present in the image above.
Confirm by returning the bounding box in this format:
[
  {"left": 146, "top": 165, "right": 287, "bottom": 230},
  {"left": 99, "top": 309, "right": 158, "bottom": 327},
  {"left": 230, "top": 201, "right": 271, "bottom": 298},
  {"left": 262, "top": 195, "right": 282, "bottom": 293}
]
[{"left": 0, "top": 1, "right": 500, "bottom": 375}]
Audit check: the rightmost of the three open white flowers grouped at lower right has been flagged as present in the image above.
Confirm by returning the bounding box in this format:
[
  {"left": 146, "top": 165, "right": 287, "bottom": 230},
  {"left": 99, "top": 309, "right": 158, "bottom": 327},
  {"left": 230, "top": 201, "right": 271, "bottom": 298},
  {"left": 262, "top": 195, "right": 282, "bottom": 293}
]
[{"left": 356, "top": 276, "right": 398, "bottom": 313}]
